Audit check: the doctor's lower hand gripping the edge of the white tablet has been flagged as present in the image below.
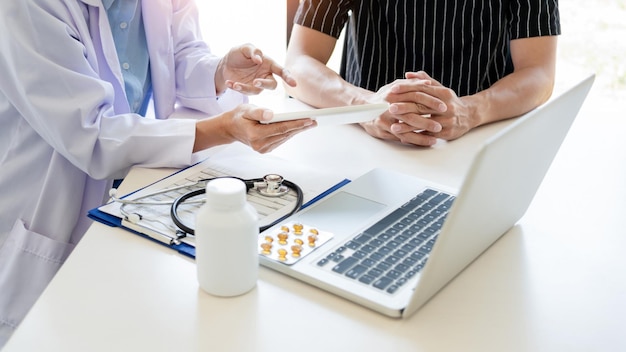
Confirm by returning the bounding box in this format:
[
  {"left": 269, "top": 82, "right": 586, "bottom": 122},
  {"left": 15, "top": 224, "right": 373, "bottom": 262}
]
[{"left": 194, "top": 104, "right": 317, "bottom": 153}]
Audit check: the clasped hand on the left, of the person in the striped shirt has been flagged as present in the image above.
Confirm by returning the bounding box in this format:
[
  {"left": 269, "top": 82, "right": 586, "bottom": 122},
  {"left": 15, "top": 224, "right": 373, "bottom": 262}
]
[{"left": 361, "top": 75, "right": 447, "bottom": 146}]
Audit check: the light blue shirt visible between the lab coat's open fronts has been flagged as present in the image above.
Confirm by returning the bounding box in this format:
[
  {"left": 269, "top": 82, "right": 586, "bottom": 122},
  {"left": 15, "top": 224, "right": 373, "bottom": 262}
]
[{"left": 102, "top": 0, "right": 151, "bottom": 115}]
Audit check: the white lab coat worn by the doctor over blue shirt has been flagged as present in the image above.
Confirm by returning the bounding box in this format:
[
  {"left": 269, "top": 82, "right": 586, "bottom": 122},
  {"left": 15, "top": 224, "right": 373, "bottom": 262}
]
[{"left": 0, "top": 0, "right": 245, "bottom": 347}]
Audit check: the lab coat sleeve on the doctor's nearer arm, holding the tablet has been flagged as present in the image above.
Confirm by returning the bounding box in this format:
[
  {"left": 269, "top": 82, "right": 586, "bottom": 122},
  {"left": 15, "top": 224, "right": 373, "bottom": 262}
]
[{"left": 0, "top": 0, "right": 195, "bottom": 179}]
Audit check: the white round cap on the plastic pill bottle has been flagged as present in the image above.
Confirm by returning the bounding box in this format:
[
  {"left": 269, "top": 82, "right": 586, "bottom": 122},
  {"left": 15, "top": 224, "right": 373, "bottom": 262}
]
[{"left": 206, "top": 177, "right": 246, "bottom": 209}]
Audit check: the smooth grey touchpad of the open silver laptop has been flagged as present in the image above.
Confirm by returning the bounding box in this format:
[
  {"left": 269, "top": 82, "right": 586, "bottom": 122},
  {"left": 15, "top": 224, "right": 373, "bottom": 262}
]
[{"left": 298, "top": 192, "right": 387, "bottom": 235}]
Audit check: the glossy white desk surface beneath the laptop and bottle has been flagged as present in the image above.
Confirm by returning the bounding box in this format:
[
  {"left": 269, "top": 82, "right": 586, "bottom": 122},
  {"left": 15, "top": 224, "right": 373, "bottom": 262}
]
[{"left": 5, "top": 77, "right": 626, "bottom": 352}]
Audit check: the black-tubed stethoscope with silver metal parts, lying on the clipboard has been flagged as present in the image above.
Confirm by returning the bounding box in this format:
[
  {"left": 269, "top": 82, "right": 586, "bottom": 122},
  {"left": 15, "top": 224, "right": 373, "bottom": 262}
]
[{"left": 109, "top": 174, "right": 304, "bottom": 238}]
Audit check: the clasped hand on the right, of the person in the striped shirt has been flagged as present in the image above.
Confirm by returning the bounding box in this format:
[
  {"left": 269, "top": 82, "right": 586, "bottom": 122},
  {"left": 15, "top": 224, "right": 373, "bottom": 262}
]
[{"left": 388, "top": 71, "right": 478, "bottom": 145}]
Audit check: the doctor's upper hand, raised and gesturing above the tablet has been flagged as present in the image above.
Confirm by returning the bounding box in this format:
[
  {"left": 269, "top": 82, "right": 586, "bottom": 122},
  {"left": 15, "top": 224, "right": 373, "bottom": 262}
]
[{"left": 215, "top": 44, "right": 296, "bottom": 95}]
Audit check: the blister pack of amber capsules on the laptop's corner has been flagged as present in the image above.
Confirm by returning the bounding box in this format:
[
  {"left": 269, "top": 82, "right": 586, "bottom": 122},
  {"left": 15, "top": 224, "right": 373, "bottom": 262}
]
[{"left": 259, "top": 222, "right": 333, "bottom": 265}]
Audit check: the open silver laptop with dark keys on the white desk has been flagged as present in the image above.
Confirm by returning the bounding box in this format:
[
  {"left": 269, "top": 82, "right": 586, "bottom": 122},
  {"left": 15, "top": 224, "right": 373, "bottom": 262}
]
[{"left": 260, "top": 75, "right": 595, "bottom": 317}]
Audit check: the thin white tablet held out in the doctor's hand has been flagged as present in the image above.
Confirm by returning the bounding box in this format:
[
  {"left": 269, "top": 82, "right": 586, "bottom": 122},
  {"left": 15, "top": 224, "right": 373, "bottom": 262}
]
[{"left": 262, "top": 103, "right": 389, "bottom": 126}]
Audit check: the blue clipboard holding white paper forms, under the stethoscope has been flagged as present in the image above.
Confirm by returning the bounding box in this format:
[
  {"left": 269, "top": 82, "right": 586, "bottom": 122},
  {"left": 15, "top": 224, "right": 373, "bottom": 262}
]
[{"left": 87, "top": 144, "right": 350, "bottom": 258}]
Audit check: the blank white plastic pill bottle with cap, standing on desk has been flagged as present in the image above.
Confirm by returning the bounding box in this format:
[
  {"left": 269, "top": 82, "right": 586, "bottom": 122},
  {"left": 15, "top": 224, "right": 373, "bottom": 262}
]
[{"left": 195, "top": 178, "right": 259, "bottom": 297}]
